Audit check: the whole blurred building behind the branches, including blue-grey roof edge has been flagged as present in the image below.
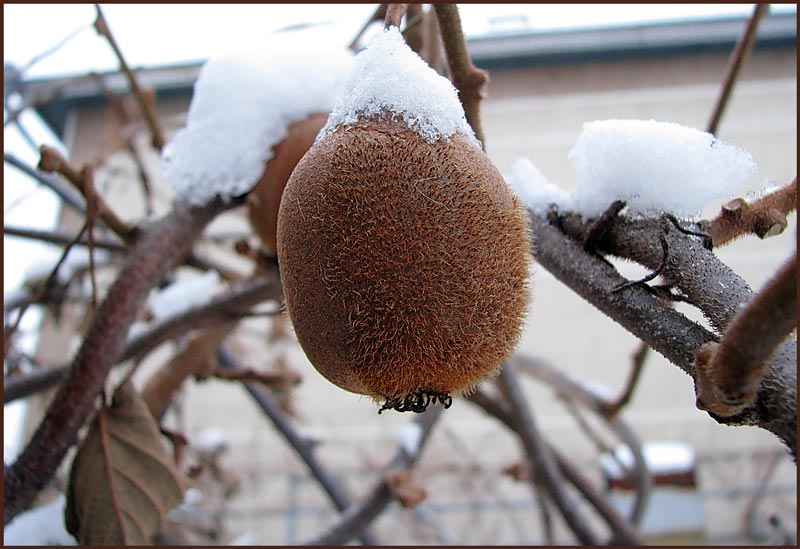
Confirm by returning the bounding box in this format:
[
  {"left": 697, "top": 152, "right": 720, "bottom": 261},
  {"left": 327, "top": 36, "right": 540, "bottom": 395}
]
[{"left": 7, "top": 6, "right": 797, "bottom": 544}]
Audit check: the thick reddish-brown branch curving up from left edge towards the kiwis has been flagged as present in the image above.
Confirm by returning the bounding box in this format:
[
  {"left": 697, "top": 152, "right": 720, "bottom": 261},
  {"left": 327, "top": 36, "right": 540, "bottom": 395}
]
[{"left": 3, "top": 196, "right": 231, "bottom": 524}]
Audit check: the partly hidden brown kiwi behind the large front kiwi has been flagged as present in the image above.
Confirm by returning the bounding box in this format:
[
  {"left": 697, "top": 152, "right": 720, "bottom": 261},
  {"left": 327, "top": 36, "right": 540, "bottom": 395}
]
[{"left": 247, "top": 113, "right": 328, "bottom": 253}]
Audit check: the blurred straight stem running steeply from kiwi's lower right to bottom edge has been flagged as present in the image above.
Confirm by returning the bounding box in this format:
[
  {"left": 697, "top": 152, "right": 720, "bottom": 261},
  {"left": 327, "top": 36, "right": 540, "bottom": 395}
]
[{"left": 497, "top": 363, "right": 600, "bottom": 545}]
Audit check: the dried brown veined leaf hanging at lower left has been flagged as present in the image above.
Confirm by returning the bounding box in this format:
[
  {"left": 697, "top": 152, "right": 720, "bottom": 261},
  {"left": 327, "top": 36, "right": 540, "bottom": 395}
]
[{"left": 64, "top": 383, "right": 184, "bottom": 545}]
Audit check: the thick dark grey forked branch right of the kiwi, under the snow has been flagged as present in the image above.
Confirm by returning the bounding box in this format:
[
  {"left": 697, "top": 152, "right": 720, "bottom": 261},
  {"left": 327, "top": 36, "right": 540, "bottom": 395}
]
[{"left": 530, "top": 208, "right": 797, "bottom": 455}]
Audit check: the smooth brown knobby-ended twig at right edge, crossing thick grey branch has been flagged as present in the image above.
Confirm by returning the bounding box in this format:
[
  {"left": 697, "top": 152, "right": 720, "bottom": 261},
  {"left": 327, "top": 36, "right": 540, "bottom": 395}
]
[{"left": 697, "top": 252, "right": 797, "bottom": 416}]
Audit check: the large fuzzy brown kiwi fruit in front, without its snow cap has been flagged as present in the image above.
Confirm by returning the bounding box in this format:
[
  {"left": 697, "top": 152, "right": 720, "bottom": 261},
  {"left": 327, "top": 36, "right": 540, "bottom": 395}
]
[{"left": 278, "top": 116, "right": 531, "bottom": 399}]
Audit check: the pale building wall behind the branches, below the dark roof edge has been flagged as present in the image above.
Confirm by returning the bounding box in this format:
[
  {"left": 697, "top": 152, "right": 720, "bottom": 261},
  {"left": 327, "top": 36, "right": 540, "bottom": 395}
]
[{"left": 53, "top": 40, "right": 797, "bottom": 543}]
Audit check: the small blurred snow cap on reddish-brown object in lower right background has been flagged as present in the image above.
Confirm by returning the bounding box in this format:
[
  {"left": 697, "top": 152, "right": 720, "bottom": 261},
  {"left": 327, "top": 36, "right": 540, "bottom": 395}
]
[{"left": 600, "top": 441, "right": 697, "bottom": 478}]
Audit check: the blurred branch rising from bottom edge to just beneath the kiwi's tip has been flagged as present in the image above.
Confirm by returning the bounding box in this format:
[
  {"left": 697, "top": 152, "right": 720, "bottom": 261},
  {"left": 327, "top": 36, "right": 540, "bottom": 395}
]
[{"left": 303, "top": 406, "right": 442, "bottom": 545}]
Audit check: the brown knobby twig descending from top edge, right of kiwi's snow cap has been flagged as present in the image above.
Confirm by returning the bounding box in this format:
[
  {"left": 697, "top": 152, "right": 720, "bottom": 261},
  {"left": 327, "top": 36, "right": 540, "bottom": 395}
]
[{"left": 433, "top": 4, "right": 489, "bottom": 146}]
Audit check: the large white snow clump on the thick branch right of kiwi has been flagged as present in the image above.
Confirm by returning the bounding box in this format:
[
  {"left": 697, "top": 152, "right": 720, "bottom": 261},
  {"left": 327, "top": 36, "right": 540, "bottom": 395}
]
[{"left": 569, "top": 120, "right": 756, "bottom": 218}]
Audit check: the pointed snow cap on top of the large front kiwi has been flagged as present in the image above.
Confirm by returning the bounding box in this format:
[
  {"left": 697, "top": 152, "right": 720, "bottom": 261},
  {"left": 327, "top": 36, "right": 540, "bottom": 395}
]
[{"left": 320, "top": 27, "right": 480, "bottom": 146}]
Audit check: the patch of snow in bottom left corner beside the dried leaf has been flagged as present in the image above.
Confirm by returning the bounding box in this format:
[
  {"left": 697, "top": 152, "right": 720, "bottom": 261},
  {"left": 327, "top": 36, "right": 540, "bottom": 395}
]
[{"left": 3, "top": 495, "right": 75, "bottom": 546}]
